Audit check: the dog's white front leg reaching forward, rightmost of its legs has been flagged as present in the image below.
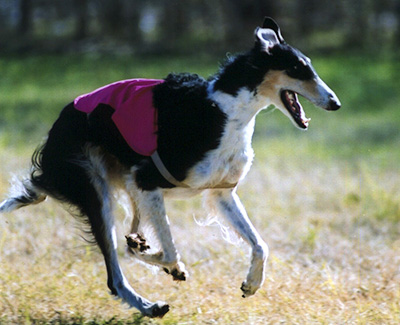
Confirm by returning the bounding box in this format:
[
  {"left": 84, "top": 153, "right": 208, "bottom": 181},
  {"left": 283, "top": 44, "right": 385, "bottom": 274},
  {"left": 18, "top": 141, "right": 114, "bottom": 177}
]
[{"left": 206, "top": 190, "right": 268, "bottom": 297}]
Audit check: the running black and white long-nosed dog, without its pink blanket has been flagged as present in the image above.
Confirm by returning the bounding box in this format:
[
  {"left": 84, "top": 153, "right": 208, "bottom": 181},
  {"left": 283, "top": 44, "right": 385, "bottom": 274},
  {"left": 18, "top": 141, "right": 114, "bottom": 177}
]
[{"left": 0, "top": 18, "right": 340, "bottom": 317}]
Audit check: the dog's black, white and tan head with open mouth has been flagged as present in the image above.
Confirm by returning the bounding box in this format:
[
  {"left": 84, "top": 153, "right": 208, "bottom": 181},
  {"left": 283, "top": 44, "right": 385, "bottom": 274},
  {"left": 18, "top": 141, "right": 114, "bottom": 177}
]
[{"left": 254, "top": 17, "right": 341, "bottom": 129}]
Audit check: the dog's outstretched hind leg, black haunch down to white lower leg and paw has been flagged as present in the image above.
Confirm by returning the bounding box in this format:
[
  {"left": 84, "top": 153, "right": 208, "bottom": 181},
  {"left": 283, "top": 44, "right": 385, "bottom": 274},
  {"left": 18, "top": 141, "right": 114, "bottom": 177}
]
[{"left": 17, "top": 106, "right": 169, "bottom": 317}]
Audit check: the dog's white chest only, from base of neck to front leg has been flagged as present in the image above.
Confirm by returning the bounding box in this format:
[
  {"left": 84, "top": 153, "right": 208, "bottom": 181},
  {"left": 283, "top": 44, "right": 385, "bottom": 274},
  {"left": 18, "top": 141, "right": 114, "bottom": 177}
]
[{"left": 185, "top": 116, "right": 254, "bottom": 187}]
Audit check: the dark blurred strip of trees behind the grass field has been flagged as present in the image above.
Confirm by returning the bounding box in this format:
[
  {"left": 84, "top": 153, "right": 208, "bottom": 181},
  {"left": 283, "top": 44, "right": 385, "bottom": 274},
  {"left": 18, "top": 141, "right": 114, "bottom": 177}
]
[{"left": 0, "top": 0, "right": 400, "bottom": 55}]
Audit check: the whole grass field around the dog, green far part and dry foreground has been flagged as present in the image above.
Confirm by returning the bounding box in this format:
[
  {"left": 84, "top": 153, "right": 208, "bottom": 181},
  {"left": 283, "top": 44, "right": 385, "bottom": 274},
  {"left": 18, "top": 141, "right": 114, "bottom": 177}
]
[{"left": 0, "top": 55, "right": 400, "bottom": 324}]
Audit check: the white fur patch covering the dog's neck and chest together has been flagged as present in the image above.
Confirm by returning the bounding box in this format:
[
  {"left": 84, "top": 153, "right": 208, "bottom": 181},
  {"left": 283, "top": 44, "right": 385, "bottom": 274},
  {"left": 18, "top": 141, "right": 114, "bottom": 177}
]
[{"left": 181, "top": 85, "right": 270, "bottom": 188}]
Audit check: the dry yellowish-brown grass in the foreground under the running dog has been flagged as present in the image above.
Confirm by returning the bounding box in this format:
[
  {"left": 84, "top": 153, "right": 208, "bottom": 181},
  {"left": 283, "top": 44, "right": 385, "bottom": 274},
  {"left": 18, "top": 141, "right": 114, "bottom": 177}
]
[{"left": 0, "top": 135, "right": 400, "bottom": 324}]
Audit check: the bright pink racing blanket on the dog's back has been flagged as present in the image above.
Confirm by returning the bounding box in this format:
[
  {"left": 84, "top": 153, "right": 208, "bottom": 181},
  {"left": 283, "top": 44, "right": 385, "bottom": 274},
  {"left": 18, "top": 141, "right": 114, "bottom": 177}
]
[{"left": 74, "top": 79, "right": 164, "bottom": 156}]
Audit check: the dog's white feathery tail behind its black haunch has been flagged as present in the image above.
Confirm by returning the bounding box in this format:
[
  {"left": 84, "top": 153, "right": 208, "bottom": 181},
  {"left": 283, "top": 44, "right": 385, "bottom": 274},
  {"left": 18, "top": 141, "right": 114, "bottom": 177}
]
[{"left": 0, "top": 175, "right": 46, "bottom": 212}]
